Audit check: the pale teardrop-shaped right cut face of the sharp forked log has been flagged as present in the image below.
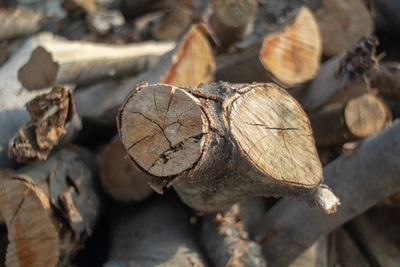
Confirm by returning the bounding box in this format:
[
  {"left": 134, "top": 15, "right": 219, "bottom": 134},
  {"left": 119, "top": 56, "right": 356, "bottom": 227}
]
[{"left": 230, "top": 84, "right": 322, "bottom": 187}]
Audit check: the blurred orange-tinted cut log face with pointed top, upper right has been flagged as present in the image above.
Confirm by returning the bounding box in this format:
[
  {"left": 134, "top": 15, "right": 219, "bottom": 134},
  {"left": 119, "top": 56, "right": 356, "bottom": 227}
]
[{"left": 259, "top": 7, "right": 322, "bottom": 86}]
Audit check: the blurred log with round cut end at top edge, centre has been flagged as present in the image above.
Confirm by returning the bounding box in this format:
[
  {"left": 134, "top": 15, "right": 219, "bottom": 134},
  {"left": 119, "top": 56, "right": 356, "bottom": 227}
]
[{"left": 208, "top": 0, "right": 258, "bottom": 52}]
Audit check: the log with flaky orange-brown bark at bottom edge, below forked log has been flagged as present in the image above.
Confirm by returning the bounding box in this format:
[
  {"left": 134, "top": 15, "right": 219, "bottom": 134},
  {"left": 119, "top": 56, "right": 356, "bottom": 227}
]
[{"left": 200, "top": 198, "right": 267, "bottom": 267}]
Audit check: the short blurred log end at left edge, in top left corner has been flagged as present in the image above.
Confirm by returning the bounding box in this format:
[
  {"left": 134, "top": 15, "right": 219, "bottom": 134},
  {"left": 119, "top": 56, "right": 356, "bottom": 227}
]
[{"left": 0, "top": 9, "right": 42, "bottom": 41}]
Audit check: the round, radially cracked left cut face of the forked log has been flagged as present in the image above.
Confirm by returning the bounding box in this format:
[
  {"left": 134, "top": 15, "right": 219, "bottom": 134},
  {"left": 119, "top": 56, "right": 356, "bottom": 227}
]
[{"left": 120, "top": 84, "right": 208, "bottom": 177}]
